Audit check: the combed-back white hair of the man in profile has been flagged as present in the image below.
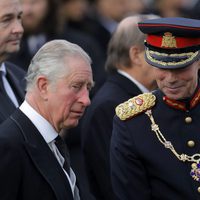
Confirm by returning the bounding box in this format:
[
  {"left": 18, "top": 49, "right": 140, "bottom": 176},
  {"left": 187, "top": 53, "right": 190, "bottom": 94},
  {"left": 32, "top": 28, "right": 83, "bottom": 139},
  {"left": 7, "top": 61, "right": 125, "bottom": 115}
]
[{"left": 26, "top": 40, "right": 92, "bottom": 91}]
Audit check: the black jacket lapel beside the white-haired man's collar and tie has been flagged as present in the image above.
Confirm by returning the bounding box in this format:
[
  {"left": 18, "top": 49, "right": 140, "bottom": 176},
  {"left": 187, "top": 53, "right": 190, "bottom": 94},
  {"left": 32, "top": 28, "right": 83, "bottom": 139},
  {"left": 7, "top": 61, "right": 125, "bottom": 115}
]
[{"left": 11, "top": 110, "right": 73, "bottom": 200}]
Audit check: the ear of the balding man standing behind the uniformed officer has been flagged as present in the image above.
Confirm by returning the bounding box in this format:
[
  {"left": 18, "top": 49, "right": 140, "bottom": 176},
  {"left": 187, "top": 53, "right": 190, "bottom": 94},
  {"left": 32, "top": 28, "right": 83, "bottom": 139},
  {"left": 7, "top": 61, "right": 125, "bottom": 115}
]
[{"left": 129, "top": 45, "right": 142, "bottom": 65}]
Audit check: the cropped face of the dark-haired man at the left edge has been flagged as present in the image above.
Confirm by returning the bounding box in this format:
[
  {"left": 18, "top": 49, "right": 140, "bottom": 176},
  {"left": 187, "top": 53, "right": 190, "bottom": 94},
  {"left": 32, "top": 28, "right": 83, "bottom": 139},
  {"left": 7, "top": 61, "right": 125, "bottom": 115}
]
[{"left": 0, "top": 0, "right": 23, "bottom": 61}]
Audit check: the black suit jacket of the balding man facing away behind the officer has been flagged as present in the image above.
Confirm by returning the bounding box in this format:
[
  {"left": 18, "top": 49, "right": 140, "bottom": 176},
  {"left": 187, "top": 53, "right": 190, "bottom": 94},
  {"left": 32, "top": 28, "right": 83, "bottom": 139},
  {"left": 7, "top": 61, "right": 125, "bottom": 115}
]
[{"left": 81, "top": 73, "right": 141, "bottom": 200}]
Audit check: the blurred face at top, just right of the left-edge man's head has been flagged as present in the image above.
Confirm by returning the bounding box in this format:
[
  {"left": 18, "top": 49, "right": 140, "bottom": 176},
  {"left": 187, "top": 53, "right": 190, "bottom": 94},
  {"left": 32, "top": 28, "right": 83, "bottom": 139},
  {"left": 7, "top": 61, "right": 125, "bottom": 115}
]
[{"left": 21, "top": 0, "right": 48, "bottom": 32}]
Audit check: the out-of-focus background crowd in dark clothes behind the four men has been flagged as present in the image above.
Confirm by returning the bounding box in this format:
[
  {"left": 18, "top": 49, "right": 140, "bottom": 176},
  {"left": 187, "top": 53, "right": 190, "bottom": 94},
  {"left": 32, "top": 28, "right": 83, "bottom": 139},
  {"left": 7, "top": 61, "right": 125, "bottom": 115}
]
[{"left": 10, "top": 0, "right": 200, "bottom": 200}]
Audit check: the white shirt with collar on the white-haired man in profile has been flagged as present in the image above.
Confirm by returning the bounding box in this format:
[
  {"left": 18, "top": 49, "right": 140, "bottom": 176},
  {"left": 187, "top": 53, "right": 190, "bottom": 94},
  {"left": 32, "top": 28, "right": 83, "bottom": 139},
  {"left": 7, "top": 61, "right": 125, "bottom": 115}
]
[{"left": 19, "top": 100, "right": 78, "bottom": 199}]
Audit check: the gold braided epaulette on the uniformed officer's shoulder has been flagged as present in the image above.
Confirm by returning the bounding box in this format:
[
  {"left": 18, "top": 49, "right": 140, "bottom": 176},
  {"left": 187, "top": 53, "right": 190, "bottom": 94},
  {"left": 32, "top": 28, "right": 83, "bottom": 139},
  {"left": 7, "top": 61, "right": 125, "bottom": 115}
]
[{"left": 115, "top": 93, "right": 156, "bottom": 120}]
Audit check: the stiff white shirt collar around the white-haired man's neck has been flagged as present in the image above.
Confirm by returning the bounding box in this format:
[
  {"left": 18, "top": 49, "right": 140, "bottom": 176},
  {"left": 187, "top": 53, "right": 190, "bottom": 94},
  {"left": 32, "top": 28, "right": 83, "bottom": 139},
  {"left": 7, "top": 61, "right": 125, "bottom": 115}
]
[{"left": 19, "top": 100, "right": 58, "bottom": 143}]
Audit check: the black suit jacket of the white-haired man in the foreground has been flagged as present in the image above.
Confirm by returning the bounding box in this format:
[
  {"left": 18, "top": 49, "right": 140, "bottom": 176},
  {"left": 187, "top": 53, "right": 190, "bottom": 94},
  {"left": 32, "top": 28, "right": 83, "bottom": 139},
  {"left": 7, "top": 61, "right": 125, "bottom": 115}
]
[{"left": 0, "top": 109, "right": 73, "bottom": 200}]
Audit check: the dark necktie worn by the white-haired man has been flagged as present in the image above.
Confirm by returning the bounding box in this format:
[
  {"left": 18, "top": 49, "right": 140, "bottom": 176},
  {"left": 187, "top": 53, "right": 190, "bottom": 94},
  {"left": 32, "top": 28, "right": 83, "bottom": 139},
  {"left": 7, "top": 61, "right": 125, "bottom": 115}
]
[{"left": 55, "top": 135, "right": 70, "bottom": 174}]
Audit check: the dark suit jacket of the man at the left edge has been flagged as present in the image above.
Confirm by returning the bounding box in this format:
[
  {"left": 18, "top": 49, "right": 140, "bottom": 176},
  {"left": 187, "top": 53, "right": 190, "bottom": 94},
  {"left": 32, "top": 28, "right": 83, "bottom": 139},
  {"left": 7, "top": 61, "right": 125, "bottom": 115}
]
[{"left": 0, "top": 62, "right": 25, "bottom": 123}]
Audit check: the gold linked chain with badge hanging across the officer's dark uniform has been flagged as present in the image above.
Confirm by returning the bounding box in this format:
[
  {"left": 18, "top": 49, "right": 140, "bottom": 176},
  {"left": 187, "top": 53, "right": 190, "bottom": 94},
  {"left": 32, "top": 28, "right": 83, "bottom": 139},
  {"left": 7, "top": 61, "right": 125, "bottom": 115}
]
[{"left": 145, "top": 110, "right": 200, "bottom": 182}]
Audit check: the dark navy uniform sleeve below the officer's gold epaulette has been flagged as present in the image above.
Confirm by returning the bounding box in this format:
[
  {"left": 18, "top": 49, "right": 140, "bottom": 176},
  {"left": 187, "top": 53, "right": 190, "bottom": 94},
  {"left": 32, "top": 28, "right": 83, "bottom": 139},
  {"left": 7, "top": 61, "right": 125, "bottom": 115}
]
[{"left": 110, "top": 116, "right": 151, "bottom": 200}]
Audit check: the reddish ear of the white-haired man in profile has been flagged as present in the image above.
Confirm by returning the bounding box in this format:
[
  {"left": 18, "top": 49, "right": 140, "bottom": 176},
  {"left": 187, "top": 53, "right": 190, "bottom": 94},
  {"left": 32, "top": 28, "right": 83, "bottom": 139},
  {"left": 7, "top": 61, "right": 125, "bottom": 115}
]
[{"left": 37, "top": 76, "right": 49, "bottom": 100}]
